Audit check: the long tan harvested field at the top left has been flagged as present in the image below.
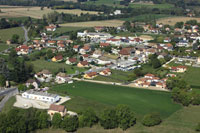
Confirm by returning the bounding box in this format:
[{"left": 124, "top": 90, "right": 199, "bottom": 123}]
[{"left": 0, "top": 6, "right": 98, "bottom": 19}]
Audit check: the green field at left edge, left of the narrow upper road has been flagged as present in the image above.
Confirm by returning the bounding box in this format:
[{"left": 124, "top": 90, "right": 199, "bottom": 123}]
[{"left": 0, "top": 27, "right": 24, "bottom": 42}]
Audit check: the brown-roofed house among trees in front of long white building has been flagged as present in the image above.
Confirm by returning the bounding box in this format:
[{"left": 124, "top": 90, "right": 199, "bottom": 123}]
[{"left": 48, "top": 104, "right": 67, "bottom": 118}]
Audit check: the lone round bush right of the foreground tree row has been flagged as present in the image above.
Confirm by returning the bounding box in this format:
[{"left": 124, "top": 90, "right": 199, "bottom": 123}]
[{"left": 142, "top": 113, "right": 162, "bottom": 127}]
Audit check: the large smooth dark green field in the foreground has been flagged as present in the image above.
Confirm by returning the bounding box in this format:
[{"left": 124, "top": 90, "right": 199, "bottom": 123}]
[{"left": 51, "top": 82, "right": 181, "bottom": 118}]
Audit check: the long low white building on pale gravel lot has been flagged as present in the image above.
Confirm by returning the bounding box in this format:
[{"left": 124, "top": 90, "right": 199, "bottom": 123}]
[{"left": 22, "top": 89, "right": 60, "bottom": 103}]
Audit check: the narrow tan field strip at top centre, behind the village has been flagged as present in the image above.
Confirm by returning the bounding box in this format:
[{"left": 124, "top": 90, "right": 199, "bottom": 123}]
[{"left": 60, "top": 20, "right": 124, "bottom": 27}]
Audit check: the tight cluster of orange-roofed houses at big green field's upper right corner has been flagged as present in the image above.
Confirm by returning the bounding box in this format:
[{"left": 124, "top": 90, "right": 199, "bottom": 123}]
[{"left": 134, "top": 74, "right": 167, "bottom": 89}]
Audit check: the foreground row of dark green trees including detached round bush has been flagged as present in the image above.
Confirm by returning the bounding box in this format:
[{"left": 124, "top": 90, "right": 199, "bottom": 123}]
[{"left": 0, "top": 105, "right": 162, "bottom": 133}]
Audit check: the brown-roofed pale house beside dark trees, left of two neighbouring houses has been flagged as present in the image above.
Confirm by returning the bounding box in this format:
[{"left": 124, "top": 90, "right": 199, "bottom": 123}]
[{"left": 34, "top": 69, "right": 52, "bottom": 82}]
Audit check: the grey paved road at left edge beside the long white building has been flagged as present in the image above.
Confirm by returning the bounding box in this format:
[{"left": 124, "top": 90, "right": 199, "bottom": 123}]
[{"left": 0, "top": 88, "right": 18, "bottom": 112}]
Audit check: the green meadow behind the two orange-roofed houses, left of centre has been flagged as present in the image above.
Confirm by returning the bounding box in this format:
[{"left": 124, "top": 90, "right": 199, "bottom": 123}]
[{"left": 30, "top": 60, "right": 86, "bottom": 74}]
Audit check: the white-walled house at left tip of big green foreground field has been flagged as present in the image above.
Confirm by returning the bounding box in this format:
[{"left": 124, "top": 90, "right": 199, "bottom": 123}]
[{"left": 55, "top": 72, "right": 73, "bottom": 84}]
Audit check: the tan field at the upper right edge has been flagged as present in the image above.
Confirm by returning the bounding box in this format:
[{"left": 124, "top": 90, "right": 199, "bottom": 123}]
[{"left": 157, "top": 17, "right": 200, "bottom": 25}]
